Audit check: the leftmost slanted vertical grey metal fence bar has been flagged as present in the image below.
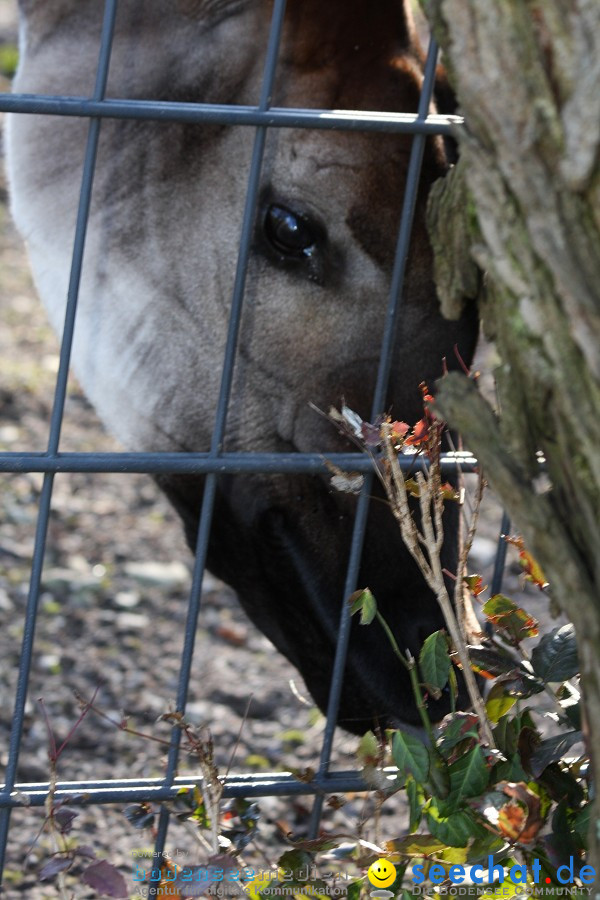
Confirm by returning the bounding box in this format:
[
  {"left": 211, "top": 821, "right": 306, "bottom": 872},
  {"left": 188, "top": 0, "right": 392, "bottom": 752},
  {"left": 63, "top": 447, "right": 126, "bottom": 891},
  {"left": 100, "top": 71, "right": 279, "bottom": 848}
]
[{"left": 0, "top": 0, "right": 117, "bottom": 874}]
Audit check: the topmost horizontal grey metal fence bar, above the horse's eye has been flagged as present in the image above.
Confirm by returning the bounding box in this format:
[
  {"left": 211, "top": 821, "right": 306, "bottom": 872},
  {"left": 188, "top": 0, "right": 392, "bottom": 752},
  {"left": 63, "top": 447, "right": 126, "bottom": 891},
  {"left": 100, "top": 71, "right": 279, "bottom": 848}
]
[{"left": 0, "top": 94, "right": 464, "bottom": 134}]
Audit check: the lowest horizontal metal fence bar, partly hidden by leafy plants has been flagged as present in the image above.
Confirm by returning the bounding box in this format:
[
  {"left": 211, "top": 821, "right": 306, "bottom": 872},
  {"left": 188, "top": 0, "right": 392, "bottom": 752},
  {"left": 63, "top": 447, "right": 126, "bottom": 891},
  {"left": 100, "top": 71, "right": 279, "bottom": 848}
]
[{"left": 0, "top": 766, "right": 398, "bottom": 808}]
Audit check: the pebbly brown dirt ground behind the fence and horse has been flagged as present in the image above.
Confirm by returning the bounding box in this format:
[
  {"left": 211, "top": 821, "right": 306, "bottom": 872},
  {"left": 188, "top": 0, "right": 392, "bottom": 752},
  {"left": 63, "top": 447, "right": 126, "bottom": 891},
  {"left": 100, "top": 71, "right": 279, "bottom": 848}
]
[{"left": 0, "top": 0, "right": 564, "bottom": 900}]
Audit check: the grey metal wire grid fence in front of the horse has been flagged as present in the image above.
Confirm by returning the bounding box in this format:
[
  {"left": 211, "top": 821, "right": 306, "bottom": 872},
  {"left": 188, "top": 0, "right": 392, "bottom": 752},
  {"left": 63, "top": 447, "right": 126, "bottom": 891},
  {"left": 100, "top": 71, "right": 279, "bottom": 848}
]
[{"left": 0, "top": 0, "right": 508, "bottom": 892}]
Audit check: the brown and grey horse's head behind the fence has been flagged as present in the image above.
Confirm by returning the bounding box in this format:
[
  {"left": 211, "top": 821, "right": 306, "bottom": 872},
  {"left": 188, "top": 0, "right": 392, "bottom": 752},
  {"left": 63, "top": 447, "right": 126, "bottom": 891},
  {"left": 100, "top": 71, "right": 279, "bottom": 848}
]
[{"left": 8, "top": 0, "right": 477, "bottom": 732}]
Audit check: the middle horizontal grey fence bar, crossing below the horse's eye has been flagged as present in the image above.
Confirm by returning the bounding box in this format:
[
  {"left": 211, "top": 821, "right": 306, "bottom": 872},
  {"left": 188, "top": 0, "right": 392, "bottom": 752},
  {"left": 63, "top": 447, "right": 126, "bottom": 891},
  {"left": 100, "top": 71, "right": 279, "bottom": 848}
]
[{"left": 0, "top": 452, "right": 478, "bottom": 475}]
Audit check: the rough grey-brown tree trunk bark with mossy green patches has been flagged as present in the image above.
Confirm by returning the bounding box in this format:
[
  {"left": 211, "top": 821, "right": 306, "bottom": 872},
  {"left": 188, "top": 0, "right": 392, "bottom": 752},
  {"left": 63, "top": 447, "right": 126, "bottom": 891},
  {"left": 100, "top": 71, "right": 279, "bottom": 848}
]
[{"left": 423, "top": 0, "right": 600, "bottom": 876}]
